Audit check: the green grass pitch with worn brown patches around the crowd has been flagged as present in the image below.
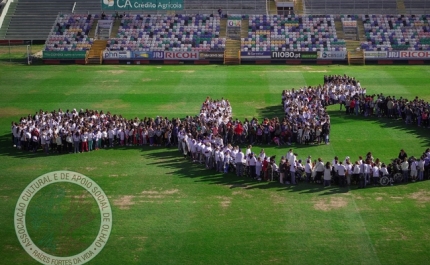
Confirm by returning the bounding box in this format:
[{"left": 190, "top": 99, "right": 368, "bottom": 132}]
[{"left": 0, "top": 64, "right": 430, "bottom": 264}]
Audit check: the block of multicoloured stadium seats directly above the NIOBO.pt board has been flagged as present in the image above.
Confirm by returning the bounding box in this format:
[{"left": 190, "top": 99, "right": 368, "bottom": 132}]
[{"left": 241, "top": 15, "right": 346, "bottom": 52}]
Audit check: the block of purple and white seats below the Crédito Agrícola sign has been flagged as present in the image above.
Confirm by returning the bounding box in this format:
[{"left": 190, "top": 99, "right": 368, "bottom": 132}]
[{"left": 108, "top": 14, "right": 225, "bottom": 51}]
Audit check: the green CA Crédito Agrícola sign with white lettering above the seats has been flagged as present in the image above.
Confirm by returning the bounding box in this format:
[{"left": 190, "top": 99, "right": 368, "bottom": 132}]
[{"left": 101, "top": 0, "right": 184, "bottom": 11}]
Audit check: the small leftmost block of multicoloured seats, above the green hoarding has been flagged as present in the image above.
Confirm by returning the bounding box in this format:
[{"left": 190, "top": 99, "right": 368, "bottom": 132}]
[{"left": 45, "top": 14, "right": 98, "bottom": 51}]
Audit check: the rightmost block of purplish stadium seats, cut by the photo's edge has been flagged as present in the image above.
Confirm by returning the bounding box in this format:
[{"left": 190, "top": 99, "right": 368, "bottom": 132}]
[{"left": 361, "top": 15, "right": 430, "bottom": 51}]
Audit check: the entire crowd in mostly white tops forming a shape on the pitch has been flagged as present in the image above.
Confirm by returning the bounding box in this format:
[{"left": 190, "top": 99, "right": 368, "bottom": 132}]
[{"left": 11, "top": 75, "right": 430, "bottom": 187}]
